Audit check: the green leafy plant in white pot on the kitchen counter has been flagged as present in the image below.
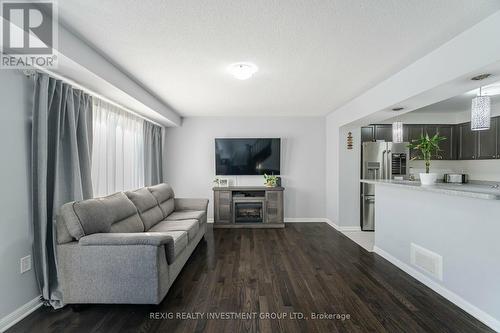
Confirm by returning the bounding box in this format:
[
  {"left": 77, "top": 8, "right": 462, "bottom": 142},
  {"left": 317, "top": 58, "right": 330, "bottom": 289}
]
[{"left": 408, "top": 133, "right": 446, "bottom": 185}]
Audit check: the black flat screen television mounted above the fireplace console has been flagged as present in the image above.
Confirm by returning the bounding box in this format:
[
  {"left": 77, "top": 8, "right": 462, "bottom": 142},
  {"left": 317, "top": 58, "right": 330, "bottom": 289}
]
[{"left": 215, "top": 138, "right": 281, "bottom": 176}]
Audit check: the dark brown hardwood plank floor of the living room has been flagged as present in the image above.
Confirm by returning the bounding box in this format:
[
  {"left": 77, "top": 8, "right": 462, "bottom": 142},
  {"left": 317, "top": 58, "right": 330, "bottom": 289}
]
[{"left": 8, "top": 223, "right": 493, "bottom": 333}]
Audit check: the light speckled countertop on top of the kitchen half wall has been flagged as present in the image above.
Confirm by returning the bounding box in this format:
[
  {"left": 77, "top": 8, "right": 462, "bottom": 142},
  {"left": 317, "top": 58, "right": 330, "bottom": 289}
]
[{"left": 361, "top": 179, "right": 500, "bottom": 200}]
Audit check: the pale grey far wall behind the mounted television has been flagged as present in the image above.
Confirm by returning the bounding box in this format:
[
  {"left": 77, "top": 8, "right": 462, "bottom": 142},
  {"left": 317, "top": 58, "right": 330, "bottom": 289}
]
[{"left": 165, "top": 117, "right": 325, "bottom": 218}]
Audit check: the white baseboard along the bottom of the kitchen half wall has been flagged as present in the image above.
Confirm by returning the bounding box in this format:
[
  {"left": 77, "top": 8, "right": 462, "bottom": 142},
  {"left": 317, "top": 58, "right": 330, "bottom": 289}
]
[{"left": 373, "top": 246, "right": 500, "bottom": 332}]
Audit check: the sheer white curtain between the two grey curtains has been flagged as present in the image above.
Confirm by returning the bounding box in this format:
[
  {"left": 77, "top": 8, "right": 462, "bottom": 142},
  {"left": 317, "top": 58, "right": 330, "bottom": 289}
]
[{"left": 92, "top": 98, "right": 144, "bottom": 197}]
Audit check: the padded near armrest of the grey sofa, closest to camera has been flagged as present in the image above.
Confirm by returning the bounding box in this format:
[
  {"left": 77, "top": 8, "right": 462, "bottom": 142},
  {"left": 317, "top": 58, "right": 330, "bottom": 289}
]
[{"left": 78, "top": 232, "right": 174, "bottom": 246}]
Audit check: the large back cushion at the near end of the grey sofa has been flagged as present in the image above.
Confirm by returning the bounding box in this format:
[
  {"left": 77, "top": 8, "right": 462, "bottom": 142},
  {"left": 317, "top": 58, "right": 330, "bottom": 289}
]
[{"left": 58, "top": 192, "right": 144, "bottom": 242}]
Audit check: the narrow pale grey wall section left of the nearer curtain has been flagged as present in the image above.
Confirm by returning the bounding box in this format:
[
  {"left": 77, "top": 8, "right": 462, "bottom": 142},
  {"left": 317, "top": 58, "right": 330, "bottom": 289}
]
[{"left": 0, "top": 70, "right": 40, "bottom": 319}]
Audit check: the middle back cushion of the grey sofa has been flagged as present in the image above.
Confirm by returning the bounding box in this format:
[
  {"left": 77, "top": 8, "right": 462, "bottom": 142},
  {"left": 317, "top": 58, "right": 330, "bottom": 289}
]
[{"left": 125, "top": 187, "right": 163, "bottom": 230}]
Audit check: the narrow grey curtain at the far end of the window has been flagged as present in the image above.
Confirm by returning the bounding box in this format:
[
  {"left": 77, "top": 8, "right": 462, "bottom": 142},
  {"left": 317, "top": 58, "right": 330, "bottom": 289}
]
[{"left": 144, "top": 121, "right": 163, "bottom": 186}]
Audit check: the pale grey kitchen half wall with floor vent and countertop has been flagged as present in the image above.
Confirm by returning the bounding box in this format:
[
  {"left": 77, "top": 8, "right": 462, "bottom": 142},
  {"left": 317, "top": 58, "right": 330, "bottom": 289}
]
[{"left": 361, "top": 180, "right": 500, "bottom": 331}]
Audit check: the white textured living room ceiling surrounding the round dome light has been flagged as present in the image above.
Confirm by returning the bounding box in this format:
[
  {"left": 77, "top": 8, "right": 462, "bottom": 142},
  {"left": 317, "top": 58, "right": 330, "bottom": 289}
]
[{"left": 58, "top": 0, "right": 500, "bottom": 116}]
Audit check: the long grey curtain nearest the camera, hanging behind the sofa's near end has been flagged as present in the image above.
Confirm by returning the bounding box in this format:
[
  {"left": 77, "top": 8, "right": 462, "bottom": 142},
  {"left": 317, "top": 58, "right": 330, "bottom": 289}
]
[{"left": 31, "top": 73, "right": 92, "bottom": 308}]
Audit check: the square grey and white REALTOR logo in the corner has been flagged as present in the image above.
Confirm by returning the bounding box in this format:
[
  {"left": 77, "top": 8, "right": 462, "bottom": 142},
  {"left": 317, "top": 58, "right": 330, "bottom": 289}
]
[{"left": 0, "top": 0, "right": 57, "bottom": 68}]
